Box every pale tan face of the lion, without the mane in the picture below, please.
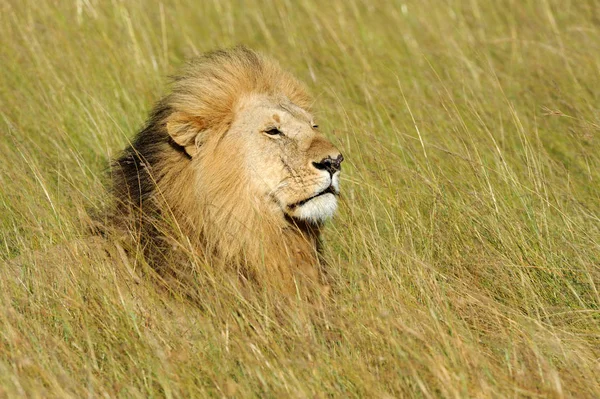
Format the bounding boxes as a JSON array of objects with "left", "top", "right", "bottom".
[{"left": 227, "top": 95, "right": 343, "bottom": 223}]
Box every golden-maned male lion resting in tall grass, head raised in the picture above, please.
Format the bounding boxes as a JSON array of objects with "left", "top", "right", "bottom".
[{"left": 112, "top": 47, "right": 344, "bottom": 288}]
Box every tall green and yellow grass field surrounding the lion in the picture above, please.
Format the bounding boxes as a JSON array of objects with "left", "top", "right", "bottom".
[{"left": 0, "top": 0, "right": 600, "bottom": 398}]
